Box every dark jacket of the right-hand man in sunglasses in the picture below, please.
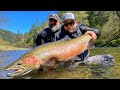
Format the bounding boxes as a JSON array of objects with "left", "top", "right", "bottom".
[{"left": 57, "top": 24, "right": 101, "bottom": 60}]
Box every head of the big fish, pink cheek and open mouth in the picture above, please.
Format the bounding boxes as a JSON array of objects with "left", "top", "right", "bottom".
[{"left": 5, "top": 56, "right": 39, "bottom": 77}]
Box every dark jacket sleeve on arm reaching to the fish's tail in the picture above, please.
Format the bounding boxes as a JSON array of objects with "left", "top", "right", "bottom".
[{"left": 79, "top": 24, "right": 101, "bottom": 38}]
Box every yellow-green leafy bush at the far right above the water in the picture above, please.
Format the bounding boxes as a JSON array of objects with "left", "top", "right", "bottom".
[{"left": 95, "top": 12, "right": 120, "bottom": 46}]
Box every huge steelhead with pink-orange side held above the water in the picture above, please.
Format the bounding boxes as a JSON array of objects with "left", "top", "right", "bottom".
[{"left": 5, "top": 35, "right": 93, "bottom": 77}]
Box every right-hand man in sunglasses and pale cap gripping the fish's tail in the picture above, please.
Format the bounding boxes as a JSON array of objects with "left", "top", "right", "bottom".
[{"left": 59, "top": 13, "right": 101, "bottom": 67}]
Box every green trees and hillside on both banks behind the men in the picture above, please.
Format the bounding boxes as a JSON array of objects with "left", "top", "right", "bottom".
[{"left": 0, "top": 11, "right": 120, "bottom": 48}]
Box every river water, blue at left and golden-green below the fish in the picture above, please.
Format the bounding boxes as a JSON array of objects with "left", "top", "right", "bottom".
[{"left": 0, "top": 47, "right": 120, "bottom": 79}]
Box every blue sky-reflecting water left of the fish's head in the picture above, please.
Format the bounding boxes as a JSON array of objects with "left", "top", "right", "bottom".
[{"left": 0, "top": 50, "right": 28, "bottom": 79}]
